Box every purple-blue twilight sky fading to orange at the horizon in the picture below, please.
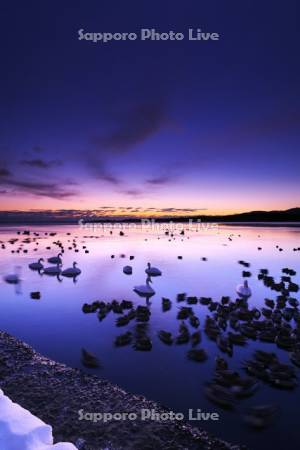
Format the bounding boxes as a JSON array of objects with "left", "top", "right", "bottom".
[{"left": 0, "top": 0, "right": 300, "bottom": 215}]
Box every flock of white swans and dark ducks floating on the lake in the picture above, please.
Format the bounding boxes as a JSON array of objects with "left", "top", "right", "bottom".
[{"left": 2, "top": 232, "right": 300, "bottom": 428}]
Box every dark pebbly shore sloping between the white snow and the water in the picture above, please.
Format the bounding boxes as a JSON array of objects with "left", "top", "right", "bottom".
[{"left": 0, "top": 331, "right": 246, "bottom": 450}]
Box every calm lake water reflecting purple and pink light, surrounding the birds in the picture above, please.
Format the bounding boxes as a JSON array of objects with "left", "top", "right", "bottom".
[{"left": 0, "top": 225, "right": 300, "bottom": 450}]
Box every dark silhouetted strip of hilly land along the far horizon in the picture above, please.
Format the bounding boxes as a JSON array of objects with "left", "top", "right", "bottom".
[{"left": 0, "top": 208, "right": 300, "bottom": 225}]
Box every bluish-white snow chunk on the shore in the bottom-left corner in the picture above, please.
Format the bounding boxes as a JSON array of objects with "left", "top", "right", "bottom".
[{"left": 0, "top": 389, "right": 76, "bottom": 450}]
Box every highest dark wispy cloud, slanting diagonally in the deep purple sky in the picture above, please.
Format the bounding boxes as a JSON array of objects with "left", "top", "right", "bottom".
[{"left": 94, "top": 103, "right": 166, "bottom": 153}]
